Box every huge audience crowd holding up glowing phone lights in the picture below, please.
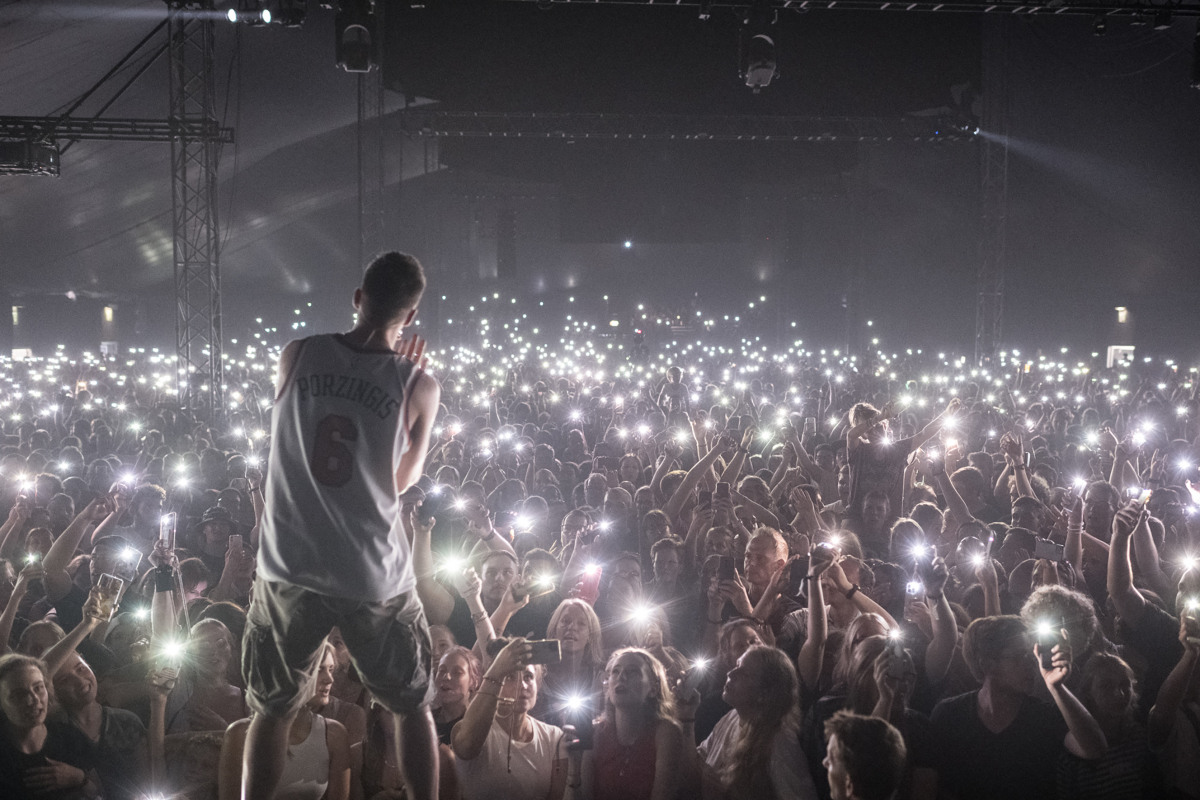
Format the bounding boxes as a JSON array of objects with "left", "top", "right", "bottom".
[{"left": 0, "top": 266, "right": 1200, "bottom": 800}]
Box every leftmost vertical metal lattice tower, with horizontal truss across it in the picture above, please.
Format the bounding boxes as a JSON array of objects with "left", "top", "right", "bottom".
[{"left": 167, "top": 0, "right": 224, "bottom": 416}]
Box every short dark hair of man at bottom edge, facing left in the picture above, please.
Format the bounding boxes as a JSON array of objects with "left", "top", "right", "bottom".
[{"left": 826, "top": 711, "right": 907, "bottom": 800}]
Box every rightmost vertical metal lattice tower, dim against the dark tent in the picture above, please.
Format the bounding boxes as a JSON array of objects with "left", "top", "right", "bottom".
[{"left": 976, "top": 17, "right": 1009, "bottom": 365}]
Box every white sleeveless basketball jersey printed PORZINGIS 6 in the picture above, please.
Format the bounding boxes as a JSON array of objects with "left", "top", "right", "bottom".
[{"left": 258, "top": 335, "right": 418, "bottom": 601}]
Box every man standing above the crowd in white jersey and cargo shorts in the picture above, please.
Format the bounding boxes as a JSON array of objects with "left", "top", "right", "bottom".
[{"left": 241, "top": 252, "right": 442, "bottom": 800}]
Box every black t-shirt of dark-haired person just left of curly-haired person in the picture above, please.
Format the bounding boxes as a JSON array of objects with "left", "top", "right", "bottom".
[{"left": 932, "top": 691, "right": 1067, "bottom": 800}]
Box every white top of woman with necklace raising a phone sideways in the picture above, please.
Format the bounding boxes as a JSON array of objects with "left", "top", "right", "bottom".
[{"left": 455, "top": 717, "right": 566, "bottom": 800}]
